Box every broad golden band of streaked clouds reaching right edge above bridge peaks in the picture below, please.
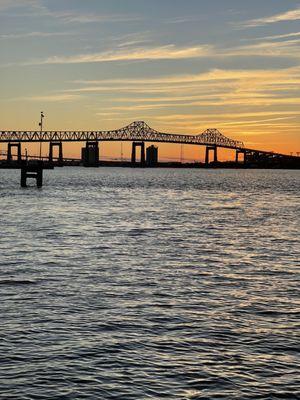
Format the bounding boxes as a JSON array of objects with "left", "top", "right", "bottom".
[{"left": 72, "top": 67, "right": 300, "bottom": 122}]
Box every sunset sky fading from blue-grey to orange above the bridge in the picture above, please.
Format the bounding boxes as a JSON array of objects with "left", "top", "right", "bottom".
[{"left": 0, "top": 0, "right": 300, "bottom": 159}]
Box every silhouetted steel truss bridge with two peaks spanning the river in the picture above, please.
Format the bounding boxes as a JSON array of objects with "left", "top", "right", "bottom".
[{"left": 0, "top": 121, "right": 298, "bottom": 164}]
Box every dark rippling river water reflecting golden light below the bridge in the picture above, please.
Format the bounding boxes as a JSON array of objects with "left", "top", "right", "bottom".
[{"left": 0, "top": 168, "right": 300, "bottom": 400}]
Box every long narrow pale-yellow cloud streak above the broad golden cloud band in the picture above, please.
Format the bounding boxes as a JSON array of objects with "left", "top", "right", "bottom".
[{"left": 23, "top": 45, "right": 210, "bottom": 65}]
